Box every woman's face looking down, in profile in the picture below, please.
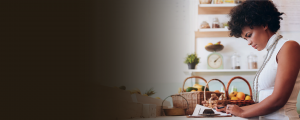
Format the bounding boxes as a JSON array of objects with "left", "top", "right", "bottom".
[{"left": 242, "top": 26, "right": 271, "bottom": 51}]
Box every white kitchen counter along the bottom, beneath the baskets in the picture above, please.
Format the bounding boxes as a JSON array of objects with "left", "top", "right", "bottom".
[{"left": 122, "top": 116, "right": 268, "bottom": 120}]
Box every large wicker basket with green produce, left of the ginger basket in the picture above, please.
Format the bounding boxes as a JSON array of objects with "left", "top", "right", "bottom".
[{"left": 172, "top": 76, "right": 223, "bottom": 115}]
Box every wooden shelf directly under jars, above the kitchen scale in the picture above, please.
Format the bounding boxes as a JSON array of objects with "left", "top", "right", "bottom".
[{"left": 195, "top": 29, "right": 230, "bottom": 38}]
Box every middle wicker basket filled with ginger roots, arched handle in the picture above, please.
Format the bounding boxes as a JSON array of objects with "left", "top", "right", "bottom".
[{"left": 202, "top": 79, "right": 230, "bottom": 108}]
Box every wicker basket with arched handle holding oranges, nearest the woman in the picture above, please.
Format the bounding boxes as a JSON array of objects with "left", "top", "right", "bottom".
[{"left": 225, "top": 76, "right": 254, "bottom": 107}]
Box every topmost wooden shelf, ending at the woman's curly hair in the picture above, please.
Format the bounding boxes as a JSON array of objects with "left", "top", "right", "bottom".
[{"left": 198, "top": 4, "right": 237, "bottom": 14}]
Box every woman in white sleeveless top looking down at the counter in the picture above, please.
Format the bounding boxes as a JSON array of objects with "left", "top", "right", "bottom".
[{"left": 216, "top": 1, "right": 300, "bottom": 120}]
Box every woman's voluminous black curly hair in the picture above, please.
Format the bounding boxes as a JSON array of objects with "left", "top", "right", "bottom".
[{"left": 228, "top": 0, "right": 284, "bottom": 38}]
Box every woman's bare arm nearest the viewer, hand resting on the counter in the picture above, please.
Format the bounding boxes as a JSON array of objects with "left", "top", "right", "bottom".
[{"left": 227, "top": 41, "right": 300, "bottom": 117}]
